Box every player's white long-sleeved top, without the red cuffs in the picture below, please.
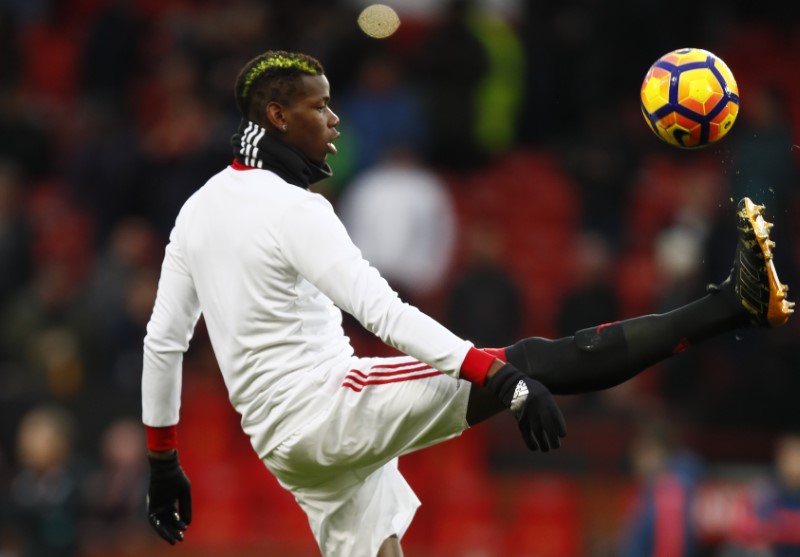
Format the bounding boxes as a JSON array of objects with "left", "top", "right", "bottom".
[{"left": 142, "top": 165, "right": 472, "bottom": 458}]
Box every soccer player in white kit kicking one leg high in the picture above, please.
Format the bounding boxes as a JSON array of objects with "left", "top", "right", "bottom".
[{"left": 142, "top": 51, "right": 792, "bottom": 557}]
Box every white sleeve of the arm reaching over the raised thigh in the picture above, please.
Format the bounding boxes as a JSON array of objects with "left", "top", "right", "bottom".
[{"left": 281, "top": 193, "right": 472, "bottom": 377}]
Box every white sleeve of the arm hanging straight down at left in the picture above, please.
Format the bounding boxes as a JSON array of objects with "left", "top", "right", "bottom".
[{"left": 142, "top": 226, "right": 200, "bottom": 427}]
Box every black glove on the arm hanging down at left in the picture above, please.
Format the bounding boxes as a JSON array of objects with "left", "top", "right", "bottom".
[{"left": 147, "top": 451, "right": 192, "bottom": 545}]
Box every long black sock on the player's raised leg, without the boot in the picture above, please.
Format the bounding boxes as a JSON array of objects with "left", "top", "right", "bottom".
[{"left": 506, "top": 288, "right": 747, "bottom": 394}]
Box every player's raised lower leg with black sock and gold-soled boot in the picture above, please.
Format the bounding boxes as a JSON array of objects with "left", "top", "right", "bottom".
[{"left": 504, "top": 198, "right": 794, "bottom": 394}]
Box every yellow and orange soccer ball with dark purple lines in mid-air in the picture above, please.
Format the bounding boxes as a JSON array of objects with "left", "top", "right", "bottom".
[{"left": 641, "top": 48, "right": 739, "bottom": 149}]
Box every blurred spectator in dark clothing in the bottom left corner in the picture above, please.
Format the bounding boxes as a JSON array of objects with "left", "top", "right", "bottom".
[{"left": 4, "top": 406, "right": 85, "bottom": 557}]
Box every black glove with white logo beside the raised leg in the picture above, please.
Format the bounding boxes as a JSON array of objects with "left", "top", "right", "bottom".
[{"left": 486, "top": 364, "right": 567, "bottom": 452}]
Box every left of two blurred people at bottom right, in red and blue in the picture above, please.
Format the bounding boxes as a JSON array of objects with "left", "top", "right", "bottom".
[{"left": 619, "top": 420, "right": 703, "bottom": 557}]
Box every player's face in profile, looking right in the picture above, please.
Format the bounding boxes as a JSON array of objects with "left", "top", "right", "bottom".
[{"left": 283, "top": 75, "right": 339, "bottom": 163}]
